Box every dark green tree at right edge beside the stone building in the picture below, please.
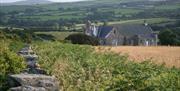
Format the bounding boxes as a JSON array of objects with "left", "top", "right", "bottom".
[{"left": 159, "top": 29, "right": 180, "bottom": 45}]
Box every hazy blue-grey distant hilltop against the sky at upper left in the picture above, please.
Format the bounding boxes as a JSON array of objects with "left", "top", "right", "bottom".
[{"left": 1, "top": 0, "right": 53, "bottom": 6}]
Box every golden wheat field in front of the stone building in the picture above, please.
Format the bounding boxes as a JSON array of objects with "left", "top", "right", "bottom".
[{"left": 96, "top": 46, "right": 180, "bottom": 68}]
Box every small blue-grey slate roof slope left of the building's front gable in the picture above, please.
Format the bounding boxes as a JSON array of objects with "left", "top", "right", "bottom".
[{"left": 98, "top": 26, "right": 113, "bottom": 38}]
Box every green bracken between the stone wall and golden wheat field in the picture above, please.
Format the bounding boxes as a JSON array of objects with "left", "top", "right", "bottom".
[{"left": 34, "top": 42, "right": 180, "bottom": 91}]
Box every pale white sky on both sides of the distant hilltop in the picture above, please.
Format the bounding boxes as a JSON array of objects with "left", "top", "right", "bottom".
[{"left": 0, "top": 0, "right": 87, "bottom": 3}]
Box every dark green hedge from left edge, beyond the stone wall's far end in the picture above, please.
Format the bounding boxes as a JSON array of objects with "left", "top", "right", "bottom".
[{"left": 0, "top": 28, "right": 55, "bottom": 42}]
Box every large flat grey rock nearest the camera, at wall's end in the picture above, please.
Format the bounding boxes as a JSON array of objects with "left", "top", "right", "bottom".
[{"left": 9, "top": 74, "right": 59, "bottom": 91}]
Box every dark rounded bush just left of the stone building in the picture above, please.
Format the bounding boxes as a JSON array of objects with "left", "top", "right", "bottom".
[{"left": 65, "top": 34, "right": 99, "bottom": 46}]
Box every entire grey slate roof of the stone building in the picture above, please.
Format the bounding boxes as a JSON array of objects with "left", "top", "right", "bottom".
[{"left": 98, "top": 24, "right": 155, "bottom": 38}]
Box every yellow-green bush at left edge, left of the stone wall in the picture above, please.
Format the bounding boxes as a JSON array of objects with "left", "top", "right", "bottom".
[{"left": 0, "top": 40, "right": 25, "bottom": 91}]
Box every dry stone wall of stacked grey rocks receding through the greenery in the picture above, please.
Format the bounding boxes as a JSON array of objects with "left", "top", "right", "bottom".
[{"left": 8, "top": 45, "right": 60, "bottom": 91}]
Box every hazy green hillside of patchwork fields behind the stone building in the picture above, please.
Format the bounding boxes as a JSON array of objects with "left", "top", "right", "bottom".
[{"left": 0, "top": 0, "right": 180, "bottom": 28}]
